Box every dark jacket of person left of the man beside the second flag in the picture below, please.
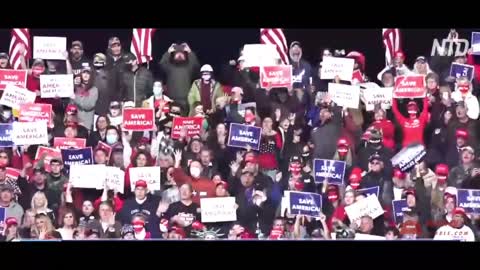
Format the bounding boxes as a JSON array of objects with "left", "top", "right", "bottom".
[{"left": 94, "top": 68, "right": 119, "bottom": 115}]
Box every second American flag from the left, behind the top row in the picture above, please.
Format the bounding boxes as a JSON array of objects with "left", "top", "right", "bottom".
[{"left": 130, "top": 28, "right": 155, "bottom": 64}]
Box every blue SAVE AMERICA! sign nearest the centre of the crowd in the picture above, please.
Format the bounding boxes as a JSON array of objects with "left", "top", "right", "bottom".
[{"left": 227, "top": 123, "right": 262, "bottom": 151}]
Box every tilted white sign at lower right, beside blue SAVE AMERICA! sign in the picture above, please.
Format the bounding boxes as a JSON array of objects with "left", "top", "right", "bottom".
[{"left": 345, "top": 194, "right": 384, "bottom": 223}]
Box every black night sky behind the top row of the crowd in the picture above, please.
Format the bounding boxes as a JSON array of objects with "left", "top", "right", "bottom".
[{"left": 0, "top": 28, "right": 475, "bottom": 79}]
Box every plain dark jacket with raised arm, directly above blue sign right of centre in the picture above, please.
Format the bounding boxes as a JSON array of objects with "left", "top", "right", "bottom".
[{"left": 310, "top": 106, "right": 342, "bottom": 159}]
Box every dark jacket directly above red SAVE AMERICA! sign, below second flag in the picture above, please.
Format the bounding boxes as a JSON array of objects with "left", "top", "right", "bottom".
[{"left": 120, "top": 66, "right": 153, "bottom": 107}]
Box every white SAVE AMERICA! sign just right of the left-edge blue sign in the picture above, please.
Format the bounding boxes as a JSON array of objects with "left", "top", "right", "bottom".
[{"left": 12, "top": 121, "right": 48, "bottom": 145}]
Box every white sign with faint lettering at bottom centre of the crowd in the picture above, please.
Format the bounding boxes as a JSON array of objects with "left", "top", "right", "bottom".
[{"left": 200, "top": 197, "right": 237, "bottom": 223}]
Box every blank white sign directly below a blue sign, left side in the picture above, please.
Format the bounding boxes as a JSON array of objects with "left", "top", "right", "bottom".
[{"left": 69, "top": 164, "right": 106, "bottom": 188}]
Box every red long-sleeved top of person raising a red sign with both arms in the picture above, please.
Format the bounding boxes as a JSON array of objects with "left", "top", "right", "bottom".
[{"left": 392, "top": 98, "right": 428, "bottom": 147}]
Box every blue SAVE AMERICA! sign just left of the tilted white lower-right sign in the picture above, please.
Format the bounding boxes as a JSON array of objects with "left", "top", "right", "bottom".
[{"left": 289, "top": 191, "right": 322, "bottom": 217}]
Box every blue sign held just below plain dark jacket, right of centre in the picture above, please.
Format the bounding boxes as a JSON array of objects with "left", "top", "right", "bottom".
[{"left": 313, "top": 159, "right": 346, "bottom": 185}]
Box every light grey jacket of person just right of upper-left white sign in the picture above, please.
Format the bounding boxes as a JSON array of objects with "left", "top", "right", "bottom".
[{"left": 72, "top": 86, "right": 98, "bottom": 130}]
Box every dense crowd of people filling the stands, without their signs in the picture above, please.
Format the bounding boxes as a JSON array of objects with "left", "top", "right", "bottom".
[{"left": 0, "top": 28, "right": 480, "bottom": 241}]
